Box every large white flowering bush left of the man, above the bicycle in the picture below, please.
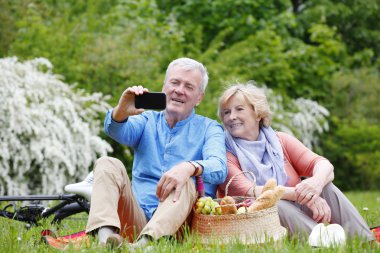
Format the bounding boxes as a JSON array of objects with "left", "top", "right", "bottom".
[{"left": 0, "top": 57, "right": 112, "bottom": 195}]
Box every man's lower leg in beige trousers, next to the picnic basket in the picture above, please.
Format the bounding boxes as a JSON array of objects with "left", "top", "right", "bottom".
[{"left": 139, "top": 179, "right": 197, "bottom": 239}]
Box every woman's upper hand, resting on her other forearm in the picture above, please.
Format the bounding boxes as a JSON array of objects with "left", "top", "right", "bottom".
[{"left": 294, "top": 176, "right": 324, "bottom": 205}]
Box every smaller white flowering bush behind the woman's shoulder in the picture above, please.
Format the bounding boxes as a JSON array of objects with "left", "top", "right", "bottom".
[{"left": 262, "top": 86, "right": 329, "bottom": 149}]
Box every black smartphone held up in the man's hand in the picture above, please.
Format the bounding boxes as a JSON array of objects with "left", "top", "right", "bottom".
[{"left": 135, "top": 92, "right": 166, "bottom": 110}]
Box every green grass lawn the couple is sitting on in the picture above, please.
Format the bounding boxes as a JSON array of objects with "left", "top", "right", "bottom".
[{"left": 0, "top": 192, "right": 380, "bottom": 253}]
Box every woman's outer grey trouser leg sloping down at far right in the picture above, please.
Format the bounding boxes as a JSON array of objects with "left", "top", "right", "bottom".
[{"left": 321, "top": 183, "right": 375, "bottom": 241}]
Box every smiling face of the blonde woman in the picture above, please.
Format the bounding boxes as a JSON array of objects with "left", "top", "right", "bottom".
[{"left": 222, "top": 94, "right": 261, "bottom": 141}]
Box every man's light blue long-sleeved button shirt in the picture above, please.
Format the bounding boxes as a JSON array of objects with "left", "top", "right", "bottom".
[{"left": 104, "top": 109, "right": 227, "bottom": 219}]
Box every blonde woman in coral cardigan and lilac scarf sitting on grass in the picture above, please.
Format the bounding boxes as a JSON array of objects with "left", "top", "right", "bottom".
[{"left": 218, "top": 84, "right": 374, "bottom": 241}]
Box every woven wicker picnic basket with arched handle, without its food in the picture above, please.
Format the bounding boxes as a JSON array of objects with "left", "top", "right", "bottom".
[{"left": 191, "top": 171, "right": 286, "bottom": 244}]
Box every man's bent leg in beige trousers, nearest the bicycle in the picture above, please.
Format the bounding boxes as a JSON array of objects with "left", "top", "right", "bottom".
[{"left": 86, "top": 157, "right": 147, "bottom": 240}]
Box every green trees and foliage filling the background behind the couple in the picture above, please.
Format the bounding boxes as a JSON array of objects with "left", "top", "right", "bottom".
[{"left": 0, "top": 0, "right": 380, "bottom": 190}]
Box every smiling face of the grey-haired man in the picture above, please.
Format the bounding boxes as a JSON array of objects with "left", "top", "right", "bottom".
[{"left": 162, "top": 66, "right": 203, "bottom": 119}]
